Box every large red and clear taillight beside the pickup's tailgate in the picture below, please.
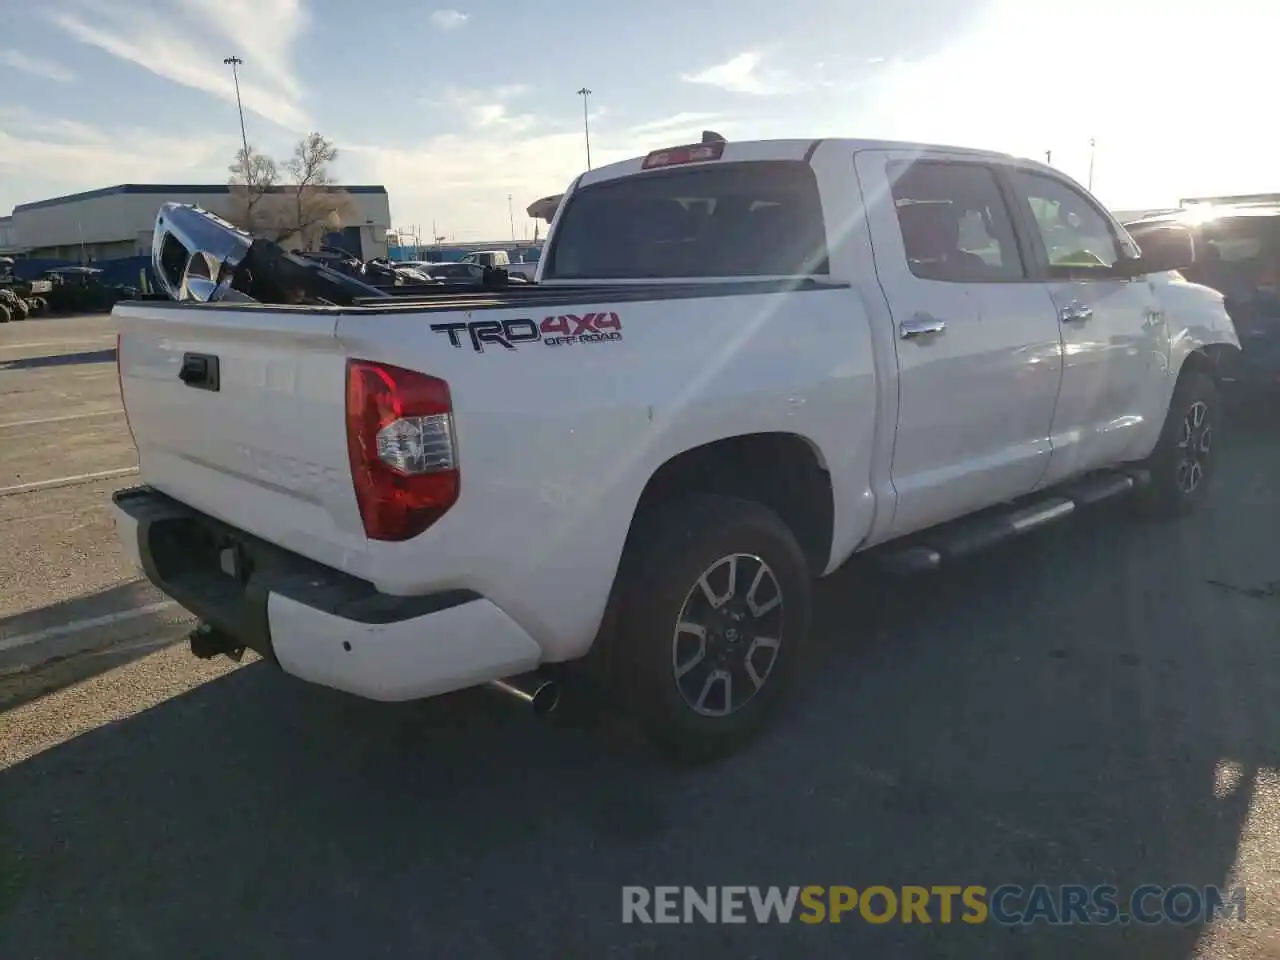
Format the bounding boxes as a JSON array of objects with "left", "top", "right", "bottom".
[{"left": 347, "top": 360, "right": 460, "bottom": 540}]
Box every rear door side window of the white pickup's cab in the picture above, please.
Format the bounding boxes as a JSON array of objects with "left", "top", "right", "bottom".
[{"left": 890, "top": 160, "right": 1025, "bottom": 283}]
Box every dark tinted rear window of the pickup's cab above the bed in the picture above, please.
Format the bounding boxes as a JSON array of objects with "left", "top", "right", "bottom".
[{"left": 543, "top": 160, "right": 829, "bottom": 280}]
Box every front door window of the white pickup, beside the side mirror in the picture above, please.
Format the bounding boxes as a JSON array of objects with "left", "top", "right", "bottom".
[{"left": 1014, "top": 170, "right": 1120, "bottom": 278}]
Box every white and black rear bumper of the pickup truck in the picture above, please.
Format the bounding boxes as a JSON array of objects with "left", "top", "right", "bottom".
[{"left": 113, "top": 486, "right": 541, "bottom": 700}]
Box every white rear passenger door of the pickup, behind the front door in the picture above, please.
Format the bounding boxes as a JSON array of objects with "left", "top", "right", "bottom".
[{"left": 855, "top": 151, "right": 1062, "bottom": 536}]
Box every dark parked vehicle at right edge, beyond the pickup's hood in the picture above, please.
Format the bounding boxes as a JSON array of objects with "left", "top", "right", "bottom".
[{"left": 1125, "top": 202, "right": 1280, "bottom": 389}]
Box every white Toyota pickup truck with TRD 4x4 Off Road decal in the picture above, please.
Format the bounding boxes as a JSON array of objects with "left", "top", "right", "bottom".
[{"left": 114, "top": 140, "right": 1239, "bottom": 755}]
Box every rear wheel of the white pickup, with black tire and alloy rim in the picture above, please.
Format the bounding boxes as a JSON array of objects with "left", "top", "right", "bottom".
[{"left": 612, "top": 495, "right": 813, "bottom": 760}]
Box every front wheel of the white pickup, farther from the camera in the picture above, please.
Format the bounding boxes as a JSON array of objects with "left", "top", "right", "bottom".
[{"left": 1137, "top": 370, "right": 1221, "bottom": 520}]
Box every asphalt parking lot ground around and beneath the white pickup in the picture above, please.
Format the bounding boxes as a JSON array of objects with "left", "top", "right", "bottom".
[{"left": 0, "top": 317, "right": 1280, "bottom": 960}]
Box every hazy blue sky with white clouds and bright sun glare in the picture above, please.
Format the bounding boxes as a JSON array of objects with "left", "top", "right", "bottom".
[{"left": 0, "top": 0, "right": 1280, "bottom": 241}]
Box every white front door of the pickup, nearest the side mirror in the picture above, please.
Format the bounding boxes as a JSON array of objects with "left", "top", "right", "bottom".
[{"left": 1010, "top": 170, "right": 1169, "bottom": 483}]
